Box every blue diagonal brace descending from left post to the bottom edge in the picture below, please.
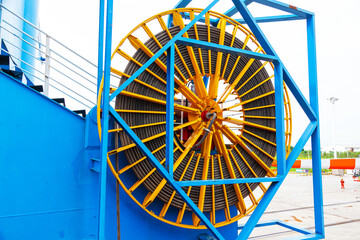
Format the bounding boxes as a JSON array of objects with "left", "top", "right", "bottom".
[{"left": 110, "top": 106, "right": 225, "bottom": 240}]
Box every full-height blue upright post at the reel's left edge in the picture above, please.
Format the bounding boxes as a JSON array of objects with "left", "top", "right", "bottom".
[{"left": 98, "top": 0, "right": 113, "bottom": 240}]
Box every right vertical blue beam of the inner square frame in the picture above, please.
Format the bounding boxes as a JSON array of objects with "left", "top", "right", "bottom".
[{"left": 274, "top": 61, "right": 286, "bottom": 176}]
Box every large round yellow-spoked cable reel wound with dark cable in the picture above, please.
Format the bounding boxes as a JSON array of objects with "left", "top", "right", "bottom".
[{"left": 100, "top": 9, "right": 291, "bottom": 228}]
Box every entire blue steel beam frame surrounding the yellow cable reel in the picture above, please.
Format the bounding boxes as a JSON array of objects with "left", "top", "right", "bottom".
[{"left": 99, "top": 0, "right": 324, "bottom": 240}]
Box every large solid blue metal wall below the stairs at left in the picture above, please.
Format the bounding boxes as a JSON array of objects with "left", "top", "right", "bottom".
[{"left": 0, "top": 73, "right": 98, "bottom": 240}]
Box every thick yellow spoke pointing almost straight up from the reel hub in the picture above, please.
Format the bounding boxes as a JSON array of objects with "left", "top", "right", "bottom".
[{"left": 209, "top": 18, "right": 226, "bottom": 99}]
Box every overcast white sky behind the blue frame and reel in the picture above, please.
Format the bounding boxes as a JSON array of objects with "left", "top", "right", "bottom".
[{"left": 40, "top": 0, "right": 360, "bottom": 151}]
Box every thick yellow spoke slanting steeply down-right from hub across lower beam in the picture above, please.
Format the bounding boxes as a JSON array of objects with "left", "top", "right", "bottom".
[{"left": 214, "top": 128, "right": 246, "bottom": 214}]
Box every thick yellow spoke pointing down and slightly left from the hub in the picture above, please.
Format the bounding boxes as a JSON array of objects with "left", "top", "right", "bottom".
[{"left": 192, "top": 132, "right": 213, "bottom": 226}]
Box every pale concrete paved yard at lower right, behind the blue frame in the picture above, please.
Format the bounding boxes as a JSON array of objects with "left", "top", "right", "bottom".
[{"left": 242, "top": 175, "right": 360, "bottom": 240}]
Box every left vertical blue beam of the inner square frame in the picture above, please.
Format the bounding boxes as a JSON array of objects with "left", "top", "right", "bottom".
[{"left": 165, "top": 45, "right": 175, "bottom": 178}]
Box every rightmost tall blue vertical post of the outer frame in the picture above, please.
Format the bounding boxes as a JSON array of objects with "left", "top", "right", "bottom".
[{"left": 306, "top": 15, "right": 325, "bottom": 236}]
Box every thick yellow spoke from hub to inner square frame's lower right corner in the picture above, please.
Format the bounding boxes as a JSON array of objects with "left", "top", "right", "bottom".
[{"left": 215, "top": 122, "right": 275, "bottom": 177}]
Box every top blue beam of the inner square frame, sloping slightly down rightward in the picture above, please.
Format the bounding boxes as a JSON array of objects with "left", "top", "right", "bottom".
[{"left": 176, "top": 37, "right": 277, "bottom": 62}]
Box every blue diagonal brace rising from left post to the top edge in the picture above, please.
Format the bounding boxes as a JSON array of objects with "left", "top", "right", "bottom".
[{"left": 110, "top": 0, "right": 219, "bottom": 101}]
